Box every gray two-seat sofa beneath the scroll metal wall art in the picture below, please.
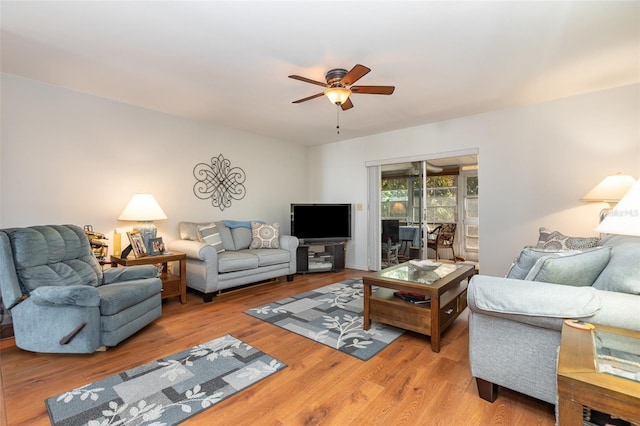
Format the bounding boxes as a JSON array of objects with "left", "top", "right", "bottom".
[{"left": 167, "top": 220, "right": 298, "bottom": 302}]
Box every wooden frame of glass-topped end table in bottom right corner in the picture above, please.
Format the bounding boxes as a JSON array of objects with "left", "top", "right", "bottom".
[{"left": 558, "top": 324, "right": 640, "bottom": 426}]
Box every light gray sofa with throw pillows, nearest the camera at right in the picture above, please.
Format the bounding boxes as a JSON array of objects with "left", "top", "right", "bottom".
[{"left": 467, "top": 235, "right": 640, "bottom": 404}]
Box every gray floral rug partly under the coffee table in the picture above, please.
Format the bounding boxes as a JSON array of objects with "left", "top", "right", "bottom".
[{"left": 245, "top": 278, "right": 403, "bottom": 361}]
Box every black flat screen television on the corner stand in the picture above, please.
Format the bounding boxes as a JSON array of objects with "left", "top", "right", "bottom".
[{"left": 291, "top": 204, "right": 351, "bottom": 242}]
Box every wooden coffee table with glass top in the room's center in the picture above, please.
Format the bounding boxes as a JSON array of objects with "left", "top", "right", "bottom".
[{"left": 362, "top": 262, "right": 476, "bottom": 352}]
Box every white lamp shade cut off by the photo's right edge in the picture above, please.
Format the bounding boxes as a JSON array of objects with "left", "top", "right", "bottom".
[{"left": 596, "top": 180, "right": 640, "bottom": 237}]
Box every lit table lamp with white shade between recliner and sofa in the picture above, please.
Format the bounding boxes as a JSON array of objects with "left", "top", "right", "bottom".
[{"left": 118, "top": 194, "right": 167, "bottom": 257}]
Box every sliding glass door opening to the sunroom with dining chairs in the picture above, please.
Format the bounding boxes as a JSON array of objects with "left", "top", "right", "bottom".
[{"left": 367, "top": 150, "right": 479, "bottom": 270}]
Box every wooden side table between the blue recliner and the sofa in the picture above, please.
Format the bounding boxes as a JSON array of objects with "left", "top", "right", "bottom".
[{"left": 111, "top": 251, "right": 187, "bottom": 304}]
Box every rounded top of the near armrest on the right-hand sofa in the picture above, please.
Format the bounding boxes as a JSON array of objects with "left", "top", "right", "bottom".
[{"left": 467, "top": 275, "right": 601, "bottom": 318}]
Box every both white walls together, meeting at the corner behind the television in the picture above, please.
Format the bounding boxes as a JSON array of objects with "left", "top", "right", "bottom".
[{"left": 0, "top": 75, "right": 640, "bottom": 275}]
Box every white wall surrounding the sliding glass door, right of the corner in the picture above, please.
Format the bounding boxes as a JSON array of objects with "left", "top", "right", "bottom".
[{"left": 309, "top": 85, "right": 640, "bottom": 275}]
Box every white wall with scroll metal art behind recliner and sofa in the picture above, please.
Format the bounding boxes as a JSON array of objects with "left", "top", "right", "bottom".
[{"left": 0, "top": 74, "right": 308, "bottom": 244}]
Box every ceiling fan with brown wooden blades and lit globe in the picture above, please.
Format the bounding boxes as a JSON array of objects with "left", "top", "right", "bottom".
[{"left": 289, "top": 64, "right": 395, "bottom": 111}]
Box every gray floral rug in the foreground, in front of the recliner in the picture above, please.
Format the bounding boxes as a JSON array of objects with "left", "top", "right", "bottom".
[{"left": 46, "top": 335, "right": 286, "bottom": 426}]
